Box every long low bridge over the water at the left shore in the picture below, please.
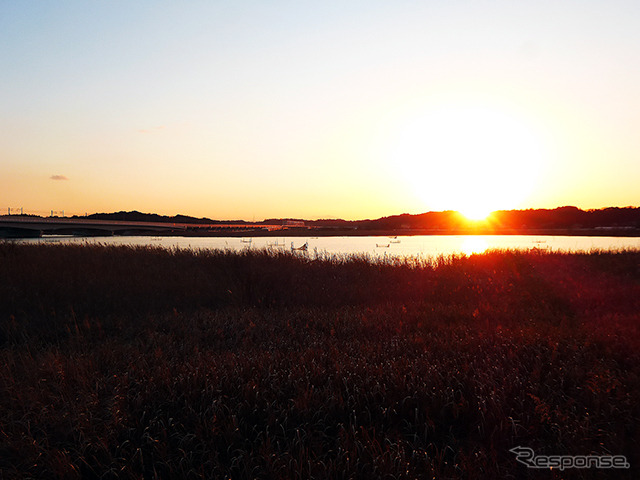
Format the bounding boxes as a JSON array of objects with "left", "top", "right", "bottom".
[{"left": 0, "top": 215, "right": 282, "bottom": 238}]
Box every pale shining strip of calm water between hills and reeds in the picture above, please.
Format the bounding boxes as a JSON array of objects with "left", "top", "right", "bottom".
[{"left": 24, "top": 235, "right": 640, "bottom": 257}]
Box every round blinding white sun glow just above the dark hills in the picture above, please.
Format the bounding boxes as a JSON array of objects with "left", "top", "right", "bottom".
[{"left": 391, "top": 105, "right": 547, "bottom": 216}]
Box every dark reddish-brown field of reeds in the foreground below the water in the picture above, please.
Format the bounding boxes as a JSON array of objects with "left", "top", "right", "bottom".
[{"left": 0, "top": 243, "right": 640, "bottom": 479}]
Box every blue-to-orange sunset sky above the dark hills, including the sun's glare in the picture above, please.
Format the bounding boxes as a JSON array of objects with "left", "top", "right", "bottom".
[{"left": 0, "top": 0, "right": 640, "bottom": 220}]
